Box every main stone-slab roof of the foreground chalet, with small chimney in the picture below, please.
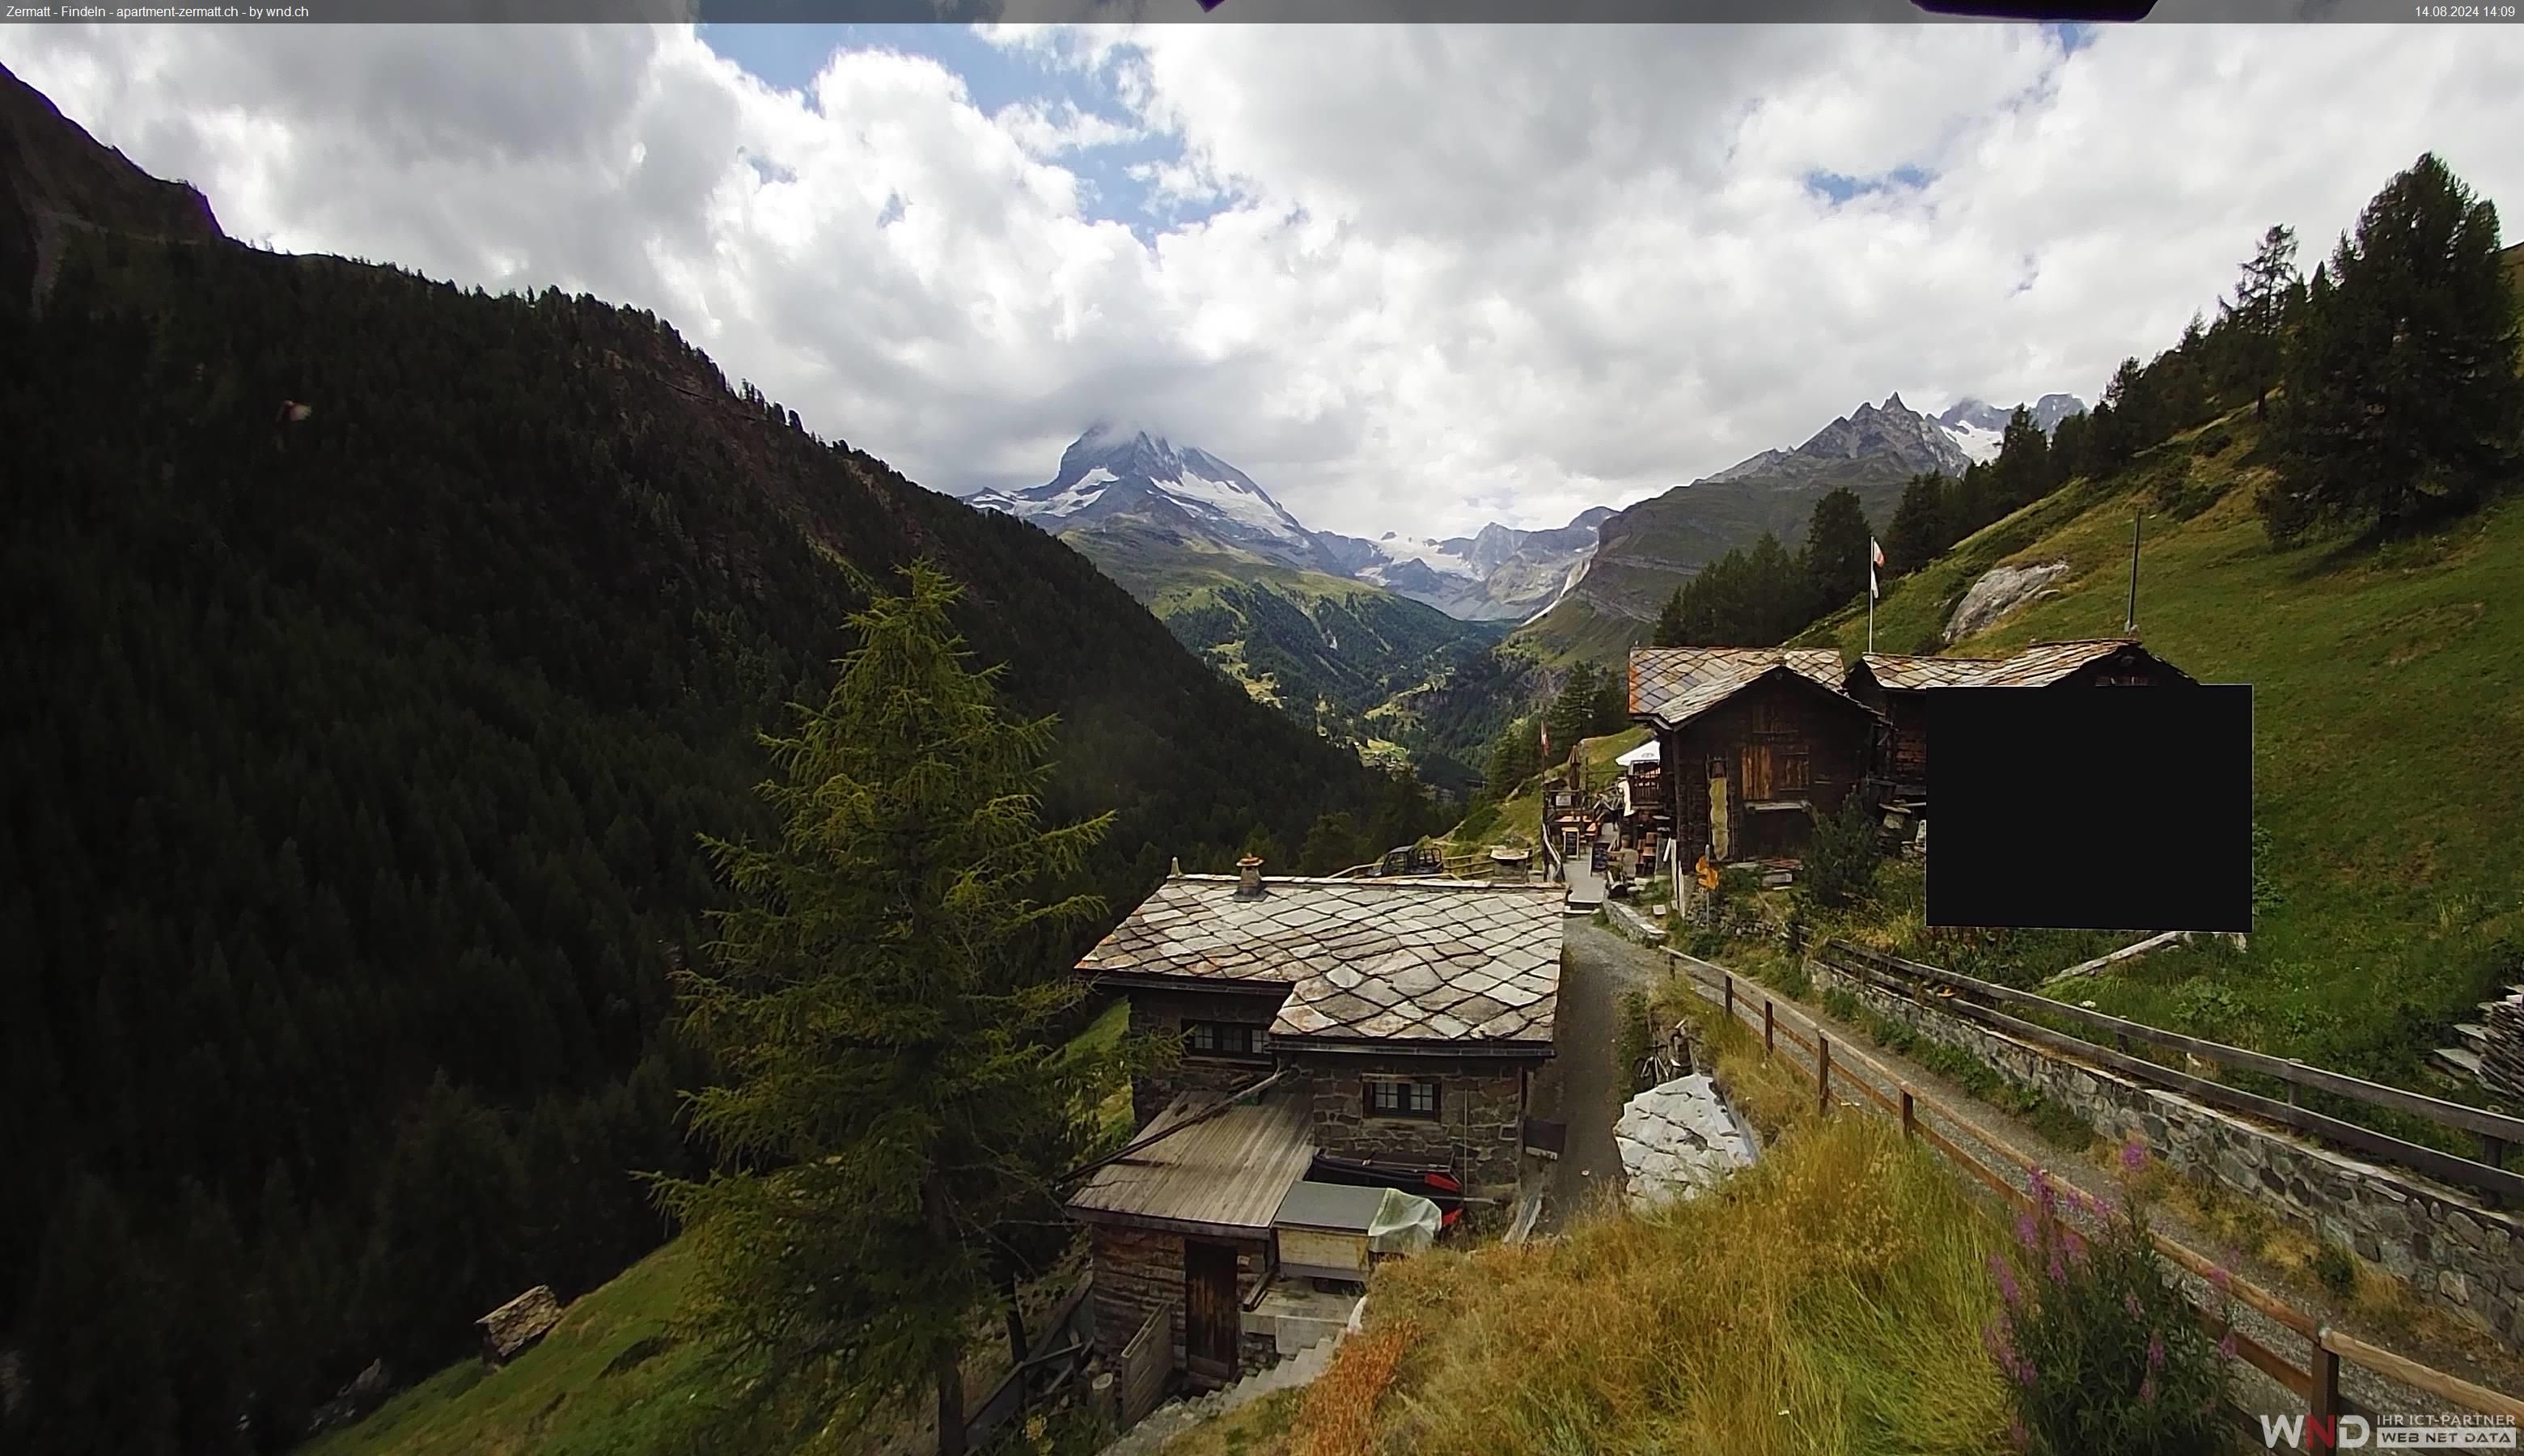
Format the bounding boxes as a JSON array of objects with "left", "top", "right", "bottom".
[{"left": 1078, "top": 875, "right": 1562, "bottom": 1050}]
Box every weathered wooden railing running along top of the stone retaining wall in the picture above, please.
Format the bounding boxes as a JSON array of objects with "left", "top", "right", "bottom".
[{"left": 1815, "top": 938, "right": 2524, "bottom": 1206}]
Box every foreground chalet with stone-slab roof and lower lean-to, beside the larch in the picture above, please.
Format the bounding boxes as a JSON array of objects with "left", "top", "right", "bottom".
[{"left": 1070, "top": 861, "right": 1562, "bottom": 1380}]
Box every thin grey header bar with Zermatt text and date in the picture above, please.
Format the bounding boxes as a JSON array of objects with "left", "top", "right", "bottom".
[{"left": 5, "top": 0, "right": 2524, "bottom": 25}]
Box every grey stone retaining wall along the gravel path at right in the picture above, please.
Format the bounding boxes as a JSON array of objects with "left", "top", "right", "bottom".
[{"left": 1807, "top": 959, "right": 2524, "bottom": 1348}]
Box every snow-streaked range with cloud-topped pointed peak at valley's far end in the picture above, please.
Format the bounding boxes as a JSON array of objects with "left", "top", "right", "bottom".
[{"left": 964, "top": 424, "right": 1613, "bottom": 620}]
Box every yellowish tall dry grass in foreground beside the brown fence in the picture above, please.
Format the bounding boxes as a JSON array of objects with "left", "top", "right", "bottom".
[{"left": 1322, "top": 963, "right": 2009, "bottom": 1456}]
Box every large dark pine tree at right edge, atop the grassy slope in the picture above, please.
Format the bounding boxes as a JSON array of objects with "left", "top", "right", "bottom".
[{"left": 2262, "top": 154, "right": 2524, "bottom": 540}]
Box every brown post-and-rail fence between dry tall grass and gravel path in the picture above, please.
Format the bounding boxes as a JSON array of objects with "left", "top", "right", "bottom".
[{"left": 1666, "top": 951, "right": 2524, "bottom": 1423}]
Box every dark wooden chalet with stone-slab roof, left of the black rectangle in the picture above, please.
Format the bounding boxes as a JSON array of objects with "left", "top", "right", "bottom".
[{"left": 1631, "top": 646, "right": 1883, "bottom": 868}]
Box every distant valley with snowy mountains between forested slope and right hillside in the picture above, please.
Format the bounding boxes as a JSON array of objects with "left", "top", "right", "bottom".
[{"left": 964, "top": 394, "right": 2085, "bottom": 787}]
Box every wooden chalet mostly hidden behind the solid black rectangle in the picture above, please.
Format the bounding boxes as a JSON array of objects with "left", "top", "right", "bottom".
[{"left": 1840, "top": 638, "right": 2193, "bottom": 807}]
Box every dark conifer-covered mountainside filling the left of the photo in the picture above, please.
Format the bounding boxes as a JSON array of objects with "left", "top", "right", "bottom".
[{"left": 0, "top": 111, "right": 1429, "bottom": 1456}]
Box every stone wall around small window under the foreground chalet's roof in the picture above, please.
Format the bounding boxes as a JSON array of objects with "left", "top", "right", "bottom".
[{"left": 1282, "top": 1052, "right": 1537, "bottom": 1199}]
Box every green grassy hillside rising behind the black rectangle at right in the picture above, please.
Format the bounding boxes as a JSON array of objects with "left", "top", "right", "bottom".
[{"left": 1800, "top": 408, "right": 2524, "bottom": 1082}]
